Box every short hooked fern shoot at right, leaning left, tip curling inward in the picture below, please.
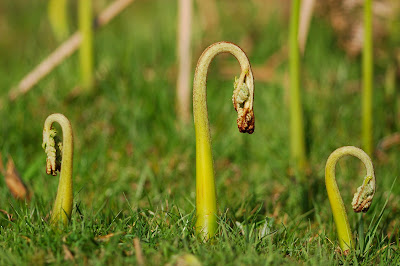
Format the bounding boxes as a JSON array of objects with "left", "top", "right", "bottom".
[{"left": 325, "top": 146, "right": 375, "bottom": 254}]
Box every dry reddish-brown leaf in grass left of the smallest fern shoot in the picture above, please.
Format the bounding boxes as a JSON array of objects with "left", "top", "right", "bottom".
[{"left": 4, "top": 156, "right": 31, "bottom": 201}]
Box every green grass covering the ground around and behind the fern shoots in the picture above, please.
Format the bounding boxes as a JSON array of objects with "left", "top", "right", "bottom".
[{"left": 0, "top": 0, "right": 400, "bottom": 265}]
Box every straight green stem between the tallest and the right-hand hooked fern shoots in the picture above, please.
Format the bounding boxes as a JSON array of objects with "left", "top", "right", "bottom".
[{"left": 289, "top": 0, "right": 306, "bottom": 175}]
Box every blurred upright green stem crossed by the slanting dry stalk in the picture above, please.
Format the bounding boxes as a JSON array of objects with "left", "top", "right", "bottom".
[{"left": 79, "top": 0, "right": 93, "bottom": 91}]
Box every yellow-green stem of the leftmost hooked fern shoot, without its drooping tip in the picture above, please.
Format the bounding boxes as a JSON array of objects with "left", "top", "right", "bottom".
[{"left": 43, "top": 114, "right": 74, "bottom": 228}]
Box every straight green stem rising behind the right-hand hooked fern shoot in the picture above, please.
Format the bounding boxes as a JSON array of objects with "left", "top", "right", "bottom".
[{"left": 362, "top": 0, "right": 373, "bottom": 155}]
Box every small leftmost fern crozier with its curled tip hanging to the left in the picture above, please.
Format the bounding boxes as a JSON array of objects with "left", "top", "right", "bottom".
[{"left": 42, "top": 114, "right": 74, "bottom": 225}]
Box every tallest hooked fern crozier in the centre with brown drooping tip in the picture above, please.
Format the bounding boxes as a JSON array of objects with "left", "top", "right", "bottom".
[{"left": 193, "top": 42, "right": 254, "bottom": 240}]
